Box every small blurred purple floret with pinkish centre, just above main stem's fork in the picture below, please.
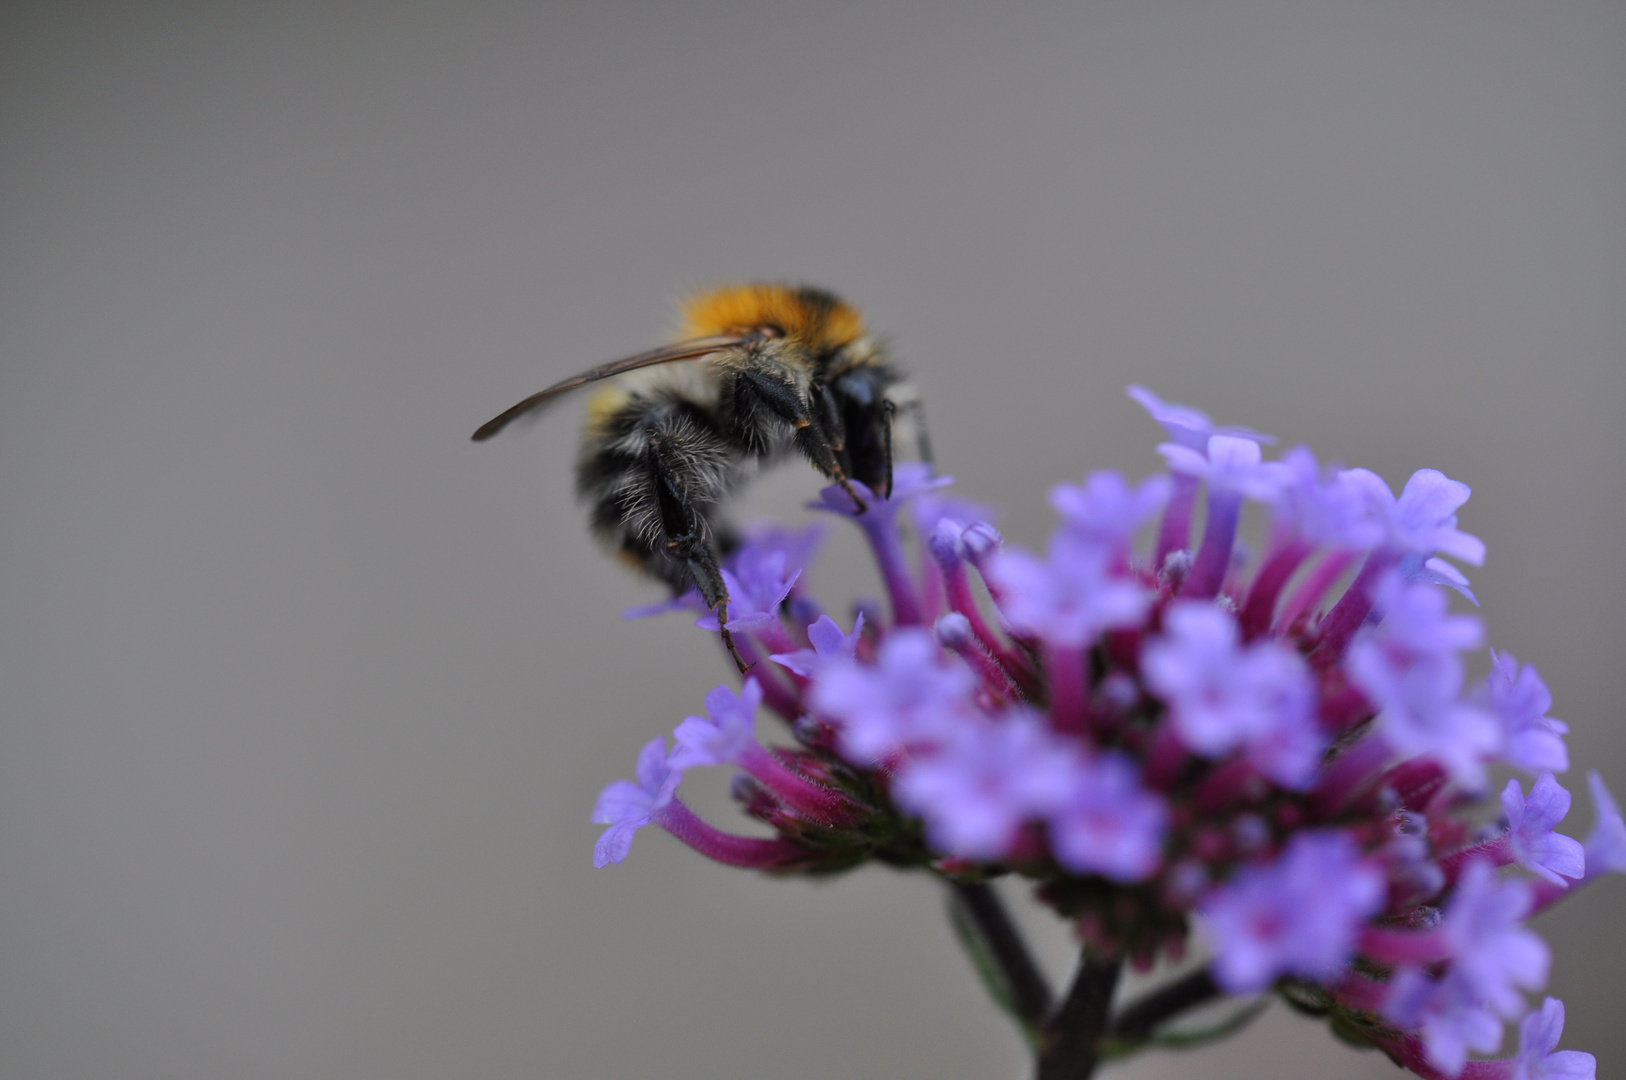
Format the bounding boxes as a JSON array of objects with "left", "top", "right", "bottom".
[{"left": 1049, "top": 753, "right": 1169, "bottom": 882}]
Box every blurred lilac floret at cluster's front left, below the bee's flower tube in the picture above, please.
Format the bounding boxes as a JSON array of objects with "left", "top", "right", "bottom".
[{"left": 813, "top": 628, "right": 976, "bottom": 764}]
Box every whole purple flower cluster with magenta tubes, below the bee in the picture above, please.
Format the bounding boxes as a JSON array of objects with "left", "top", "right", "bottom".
[{"left": 593, "top": 387, "right": 1626, "bottom": 1077}]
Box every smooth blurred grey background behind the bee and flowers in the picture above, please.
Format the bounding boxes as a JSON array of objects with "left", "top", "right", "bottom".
[{"left": 0, "top": 0, "right": 1626, "bottom": 1080}]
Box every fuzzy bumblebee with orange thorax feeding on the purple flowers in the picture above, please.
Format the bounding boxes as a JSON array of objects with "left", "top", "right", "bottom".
[{"left": 473, "top": 285, "right": 927, "bottom": 672}]
